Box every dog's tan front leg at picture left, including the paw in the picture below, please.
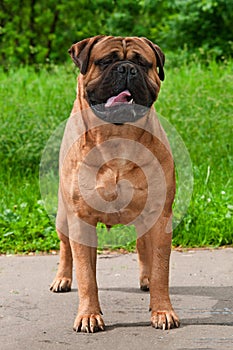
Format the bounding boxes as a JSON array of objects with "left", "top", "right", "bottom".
[{"left": 70, "top": 240, "right": 105, "bottom": 333}]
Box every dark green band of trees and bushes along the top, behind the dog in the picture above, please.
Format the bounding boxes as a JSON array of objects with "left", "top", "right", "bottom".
[{"left": 0, "top": 0, "right": 233, "bottom": 69}]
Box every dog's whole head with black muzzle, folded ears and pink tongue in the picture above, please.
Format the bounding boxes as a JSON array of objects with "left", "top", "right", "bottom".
[{"left": 69, "top": 36, "right": 165, "bottom": 124}]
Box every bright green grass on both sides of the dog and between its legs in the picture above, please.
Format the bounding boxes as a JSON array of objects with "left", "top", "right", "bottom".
[{"left": 0, "top": 57, "right": 233, "bottom": 253}]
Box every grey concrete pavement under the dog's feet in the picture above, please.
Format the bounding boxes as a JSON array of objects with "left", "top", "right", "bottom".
[{"left": 0, "top": 248, "right": 233, "bottom": 350}]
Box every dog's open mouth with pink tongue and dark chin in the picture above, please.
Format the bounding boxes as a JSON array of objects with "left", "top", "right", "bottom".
[{"left": 90, "top": 90, "right": 148, "bottom": 125}]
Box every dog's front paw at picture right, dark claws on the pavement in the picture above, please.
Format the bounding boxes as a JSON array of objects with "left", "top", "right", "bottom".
[{"left": 151, "top": 310, "right": 180, "bottom": 330}]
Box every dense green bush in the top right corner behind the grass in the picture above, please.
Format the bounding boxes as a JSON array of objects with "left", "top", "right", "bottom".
[{"left": 163, "top": 0, "right": 233, "bottom": 59}]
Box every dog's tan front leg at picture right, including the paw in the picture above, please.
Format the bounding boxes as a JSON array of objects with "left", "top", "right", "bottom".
[{"left": 150, "top": 217, "right": 179, "bottom": 329}]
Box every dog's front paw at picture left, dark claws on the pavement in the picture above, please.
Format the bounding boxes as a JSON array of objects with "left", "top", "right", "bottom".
[{"left": 73, "top": 314, "right": 105, "bottom": 333}]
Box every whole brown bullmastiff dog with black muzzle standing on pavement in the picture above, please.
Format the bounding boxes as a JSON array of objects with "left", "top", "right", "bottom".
[{"left": 50, "top": 36, "right": 179, "bottom": 332}]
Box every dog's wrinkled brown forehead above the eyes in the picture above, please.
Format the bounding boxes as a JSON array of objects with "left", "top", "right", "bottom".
[{"left": 92, "top": 37, "right": 155, "bottom": 62}]
